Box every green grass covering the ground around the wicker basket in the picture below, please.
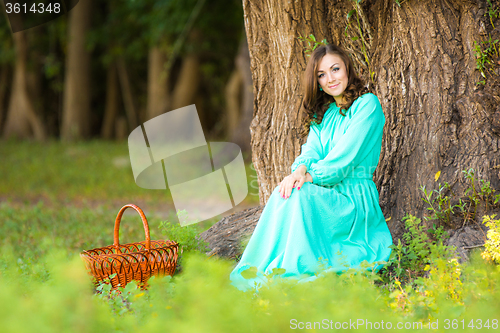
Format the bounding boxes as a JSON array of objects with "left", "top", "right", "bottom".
[{"left": 0, "top": 142, "right": 500, "bottom": 333}]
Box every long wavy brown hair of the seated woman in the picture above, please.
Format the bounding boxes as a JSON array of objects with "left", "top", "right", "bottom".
[{"left": 300, "top": 44, "right": 369, "bottom": 137}]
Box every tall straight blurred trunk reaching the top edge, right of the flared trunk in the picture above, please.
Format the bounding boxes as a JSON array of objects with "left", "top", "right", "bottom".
[{"left": 61, "top": 0, "right": 92, "bottom": 140}]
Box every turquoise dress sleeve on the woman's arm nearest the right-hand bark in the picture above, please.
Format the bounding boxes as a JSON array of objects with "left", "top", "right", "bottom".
[{"left": 307, "top": 93, "right": 385, "bottom": 185}]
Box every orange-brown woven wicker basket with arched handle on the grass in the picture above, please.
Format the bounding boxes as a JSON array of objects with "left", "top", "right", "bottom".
[{"left": 80, "top": 204, "right": 179, "bottom": 289}]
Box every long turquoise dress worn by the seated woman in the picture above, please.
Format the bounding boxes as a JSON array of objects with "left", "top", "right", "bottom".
[{"left": 229, "top": 93, "right": 392, "bottom": 290}]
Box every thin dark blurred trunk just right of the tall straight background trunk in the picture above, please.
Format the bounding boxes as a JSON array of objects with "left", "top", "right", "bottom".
[{"left": 101, "top": 62, "right": 120, "bottom": 140}]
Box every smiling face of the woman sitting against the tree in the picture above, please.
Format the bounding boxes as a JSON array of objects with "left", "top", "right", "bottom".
[{"left": 316, "top": 53, "right": 349, "bottom": 105}]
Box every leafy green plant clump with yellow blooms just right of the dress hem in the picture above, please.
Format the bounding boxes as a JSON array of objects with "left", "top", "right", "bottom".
[{"left": 382, "top": 214, "right": 463, "bottom": 318}]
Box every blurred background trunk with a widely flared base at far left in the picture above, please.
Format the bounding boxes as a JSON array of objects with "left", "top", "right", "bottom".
[{"left": 3, "top": 31, "right": 45, "bottom": 140}]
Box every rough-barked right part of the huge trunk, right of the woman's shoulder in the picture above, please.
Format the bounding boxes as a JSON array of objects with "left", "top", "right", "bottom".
[{"left": 369, "top": 1, "right": 500, "bottom": 236}]
